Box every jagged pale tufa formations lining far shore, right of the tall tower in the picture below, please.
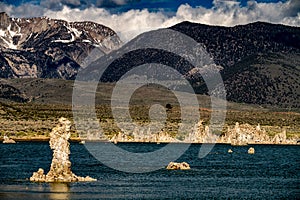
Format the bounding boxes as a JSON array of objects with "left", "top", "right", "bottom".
[{"left": 105, "top": 121, "right": 297, "bottom": 145}]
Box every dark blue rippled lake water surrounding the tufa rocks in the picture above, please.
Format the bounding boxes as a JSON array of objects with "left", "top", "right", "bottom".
[{"left": 0, "top": 142, "right": 300, "bottom": 199}]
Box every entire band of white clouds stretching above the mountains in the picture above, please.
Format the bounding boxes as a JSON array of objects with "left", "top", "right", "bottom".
[{"left": 4, "top": 0, "right": 300, "bottom": 42}]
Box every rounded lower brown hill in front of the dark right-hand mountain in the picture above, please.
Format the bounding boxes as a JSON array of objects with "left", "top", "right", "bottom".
[{"left": 222, "top": 53, "right": 300, "bottom": 108}]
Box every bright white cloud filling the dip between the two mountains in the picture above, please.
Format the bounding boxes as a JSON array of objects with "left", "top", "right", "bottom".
[{"left": 45, "top": 7, "right": 169, "bottom": 41}]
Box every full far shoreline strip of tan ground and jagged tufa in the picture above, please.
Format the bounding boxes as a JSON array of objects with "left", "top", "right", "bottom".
[{"left": 0, "top": 121, "right": 300, "bottom": 146}]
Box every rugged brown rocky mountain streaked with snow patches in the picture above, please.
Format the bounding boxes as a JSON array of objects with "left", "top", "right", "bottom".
[{"left": 0, "top": 13, "right": 121, "bottom": 79}]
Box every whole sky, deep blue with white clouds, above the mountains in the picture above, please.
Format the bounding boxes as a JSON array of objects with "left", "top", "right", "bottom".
[{"left": 0, "top": 0, "right": 300, "bottom": 42}]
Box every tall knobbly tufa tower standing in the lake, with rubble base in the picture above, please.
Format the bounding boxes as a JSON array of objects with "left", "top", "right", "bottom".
[{"left": 30, "top": 117, "right": 97, "bottom": 182}]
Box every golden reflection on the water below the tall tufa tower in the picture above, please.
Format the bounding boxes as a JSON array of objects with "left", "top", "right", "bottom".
[{"left": 50, "top": 183, "right": 70, "bottom": 200}]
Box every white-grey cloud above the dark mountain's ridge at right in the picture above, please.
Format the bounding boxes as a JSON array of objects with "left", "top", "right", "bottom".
[{"left": 171, "top": 1, "right": 300, "bottom": 26}]
